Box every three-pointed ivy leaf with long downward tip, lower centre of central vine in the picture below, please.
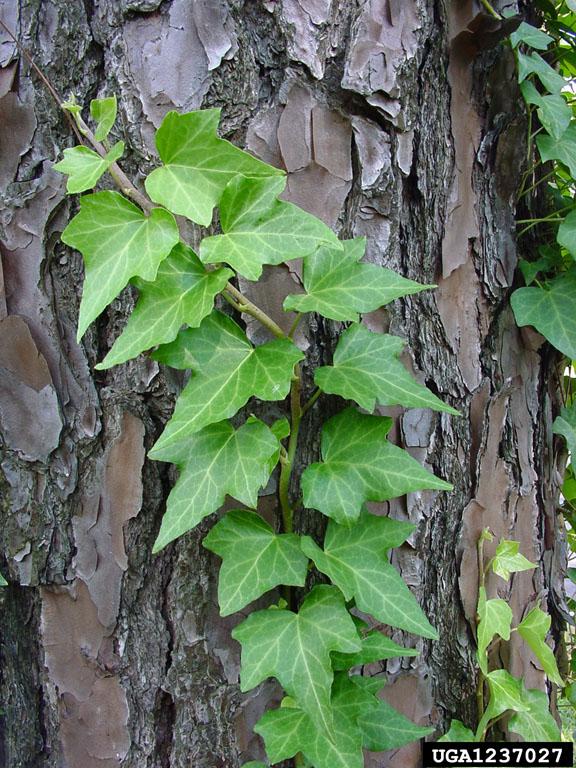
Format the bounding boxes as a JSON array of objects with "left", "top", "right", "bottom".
[{"left": 232, "top": 585, "right": 361, "bottom": 733}]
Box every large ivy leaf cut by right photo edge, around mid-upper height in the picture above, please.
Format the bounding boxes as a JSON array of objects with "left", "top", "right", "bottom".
[{"left": 510, "top": 272, "right": 576, "bottom": 360}]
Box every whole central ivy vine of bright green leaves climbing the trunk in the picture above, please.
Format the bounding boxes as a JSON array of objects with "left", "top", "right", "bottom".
[{"left": 57, "top": 98, "right": 456, "bottom": 768}]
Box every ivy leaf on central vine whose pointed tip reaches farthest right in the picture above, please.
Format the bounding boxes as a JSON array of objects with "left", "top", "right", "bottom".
[{"left": 314, "top": 325, "right": 458, "bottom": 415}]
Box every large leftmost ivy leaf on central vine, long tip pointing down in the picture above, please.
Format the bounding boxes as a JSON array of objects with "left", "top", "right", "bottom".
[{"left": 62, "top": 190, "right": 180, "bottom": 340}]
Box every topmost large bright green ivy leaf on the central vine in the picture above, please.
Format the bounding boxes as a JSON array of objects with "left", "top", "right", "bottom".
[{"left": 145, "top": 109, "right": 283, "bottom": 227}]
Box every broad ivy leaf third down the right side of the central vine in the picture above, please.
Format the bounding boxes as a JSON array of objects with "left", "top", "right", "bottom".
[{"left": 302, "top": 408, "right": 452, "bottom": 522}]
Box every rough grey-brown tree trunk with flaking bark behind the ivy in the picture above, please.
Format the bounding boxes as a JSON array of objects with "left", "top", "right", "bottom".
[{"left": 0, "top": 0, "right": 563, "bottom": 768}]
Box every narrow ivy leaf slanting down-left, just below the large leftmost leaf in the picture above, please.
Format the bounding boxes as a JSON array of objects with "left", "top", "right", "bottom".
[{"left": 96, "top": 243, "right": 233, "bottom": 370}]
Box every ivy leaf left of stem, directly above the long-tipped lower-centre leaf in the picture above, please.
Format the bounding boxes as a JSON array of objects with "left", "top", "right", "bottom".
[{"left": 203, "top": 510, "right": 308, "bottom": 616}]
